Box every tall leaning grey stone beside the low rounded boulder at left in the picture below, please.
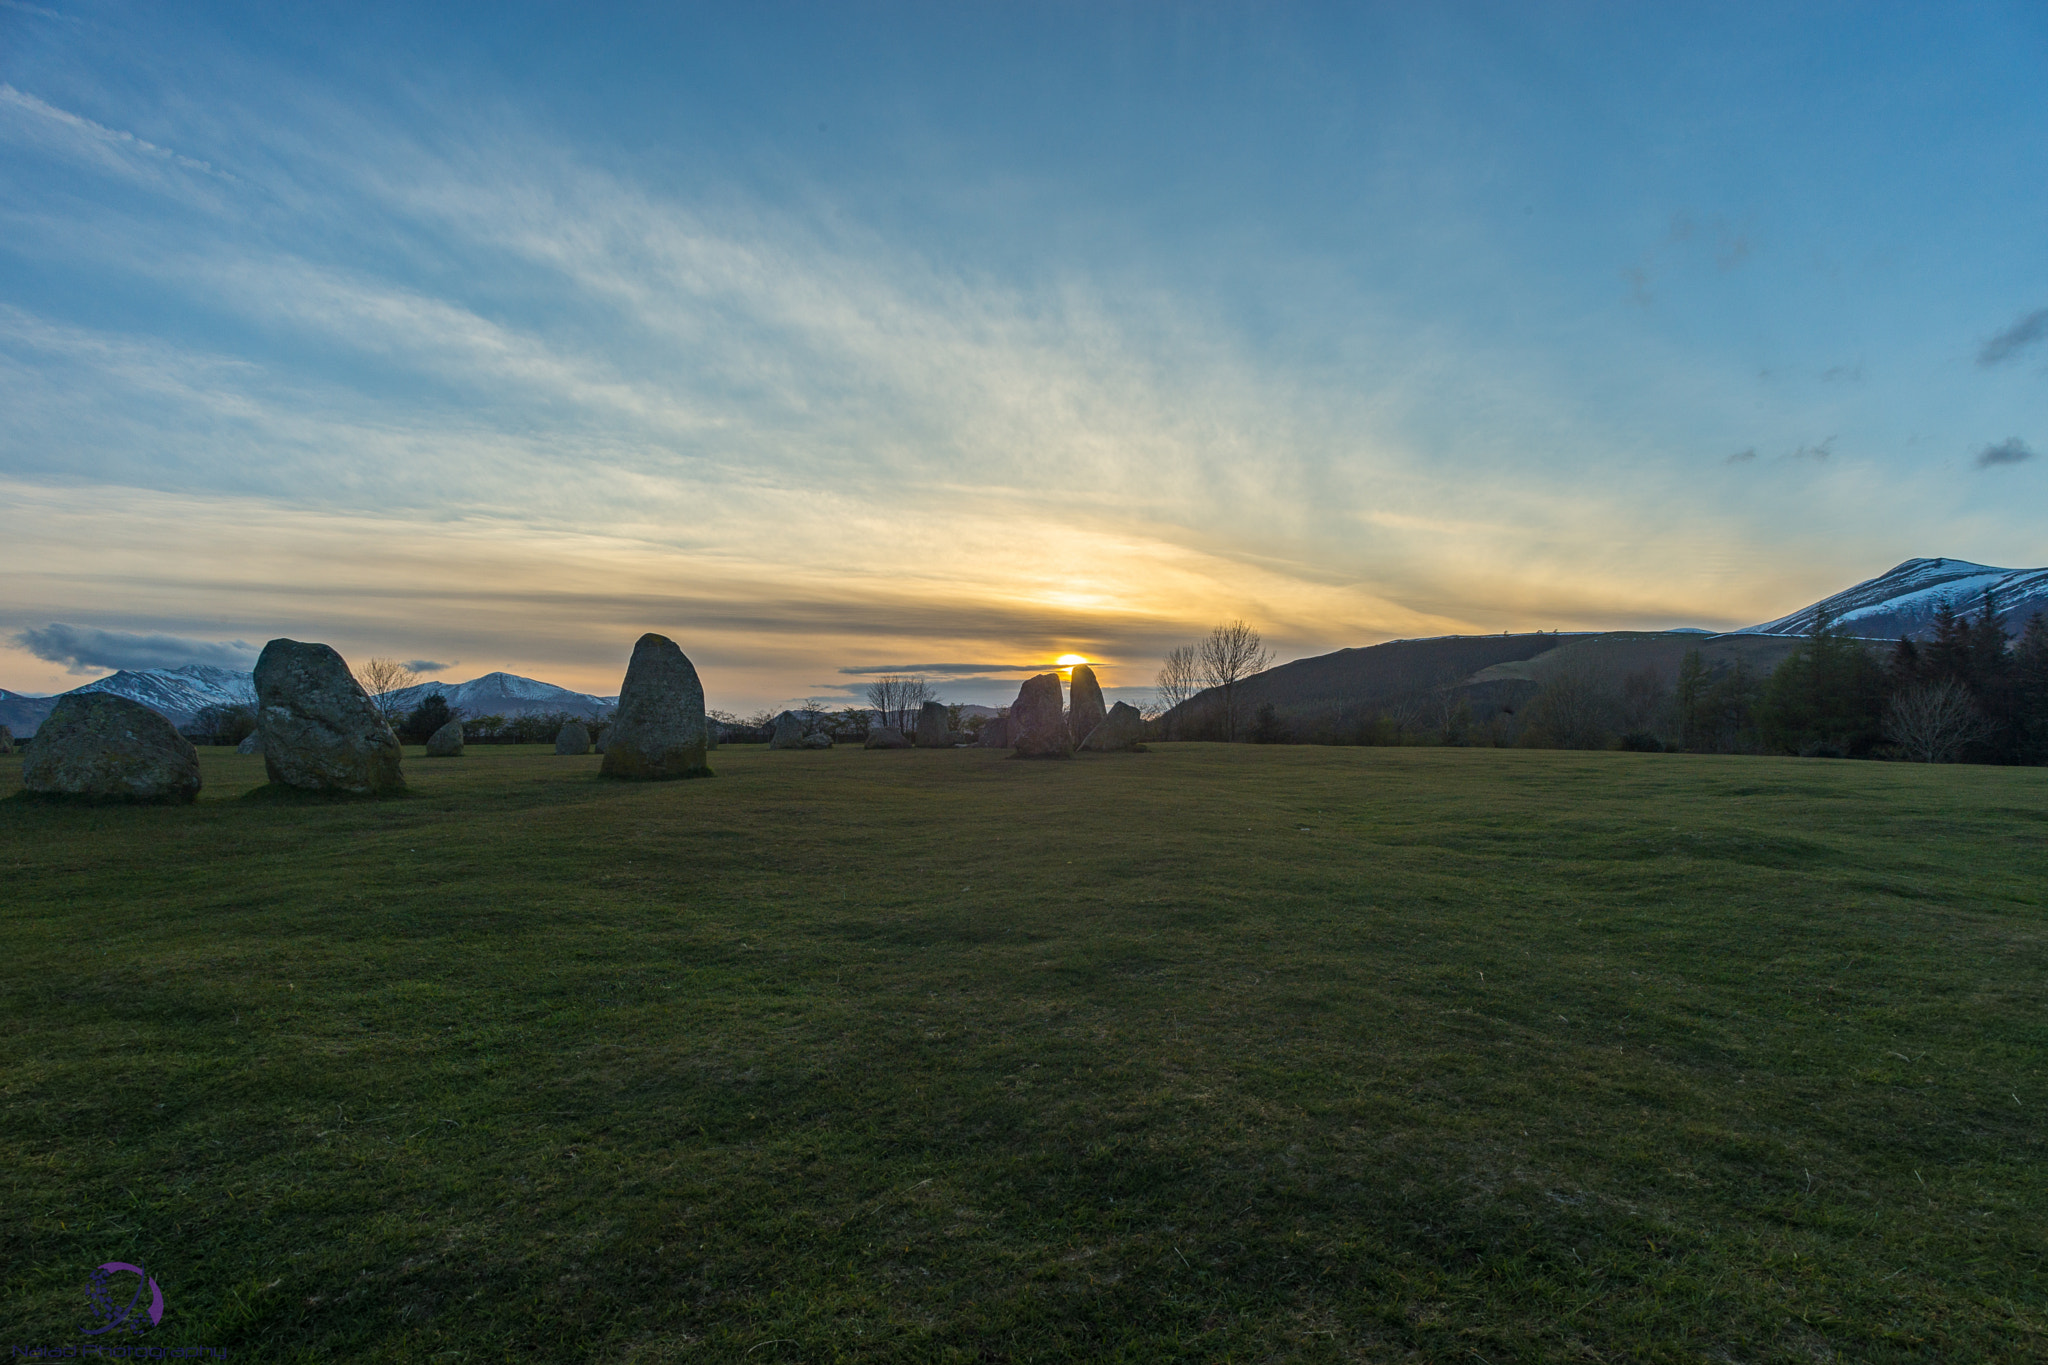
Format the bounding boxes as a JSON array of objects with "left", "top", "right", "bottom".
[{"left": 256, "top": 641, "right": 406, "bottom": 796}]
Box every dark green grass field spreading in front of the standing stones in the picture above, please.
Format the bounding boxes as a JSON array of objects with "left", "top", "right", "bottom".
[{"left": 0, "top": 745, "right": 2048, "bottom": 1363}]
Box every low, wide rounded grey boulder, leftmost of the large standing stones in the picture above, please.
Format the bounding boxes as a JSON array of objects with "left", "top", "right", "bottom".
[{"left": 20, "top": 692, "right": 199, "bottom": 802}]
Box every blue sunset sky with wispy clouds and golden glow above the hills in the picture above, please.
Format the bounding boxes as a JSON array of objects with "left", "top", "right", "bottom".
[{"left": 0, "top": 0, "right": 2048, "bottom": 712}]
